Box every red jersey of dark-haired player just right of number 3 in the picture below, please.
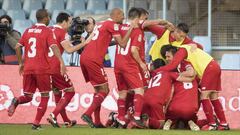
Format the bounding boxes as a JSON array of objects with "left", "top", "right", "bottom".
[{"left": 48, "top": 25, "right": 70, "bottom": 74}]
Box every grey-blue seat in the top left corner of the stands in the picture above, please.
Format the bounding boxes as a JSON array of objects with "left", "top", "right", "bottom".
[{"left": 2, "top": 0, "right": 22, "bottom": 11}]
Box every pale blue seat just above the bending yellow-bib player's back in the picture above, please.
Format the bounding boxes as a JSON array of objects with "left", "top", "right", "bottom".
[{"left": 193, "top": 36, "right": 212, "bottom": 54}]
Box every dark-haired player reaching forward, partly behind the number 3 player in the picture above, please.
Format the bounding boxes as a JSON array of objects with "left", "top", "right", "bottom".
[{"left": 47, "top": 13, "right": 89, "bottom": 127}]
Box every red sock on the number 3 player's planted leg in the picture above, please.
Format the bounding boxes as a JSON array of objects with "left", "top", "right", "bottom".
[{"left": 33, "top": 97, "right": 49, "bottom": 125}]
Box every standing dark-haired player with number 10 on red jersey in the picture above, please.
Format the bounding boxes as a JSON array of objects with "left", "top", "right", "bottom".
[{"left": 114, "top": 7, "right": 147, "bottom": 128}]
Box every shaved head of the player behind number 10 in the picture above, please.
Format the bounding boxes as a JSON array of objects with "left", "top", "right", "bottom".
[{"left": 110, "top": 8, "right": 124, "bottom": 23}]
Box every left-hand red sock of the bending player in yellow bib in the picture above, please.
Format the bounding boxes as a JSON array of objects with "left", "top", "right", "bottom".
[{"left": 202, "top": 99, "right": 215, "bottom": 124}]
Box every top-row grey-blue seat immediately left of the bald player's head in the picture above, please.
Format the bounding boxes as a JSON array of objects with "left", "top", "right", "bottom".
[{"left": 87, "top": 0, "right": 106, "bottom": 12}]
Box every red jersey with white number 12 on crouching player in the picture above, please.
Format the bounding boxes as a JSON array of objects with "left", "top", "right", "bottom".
[{"left": 145, "top": 71, "right": 178, "bottom": 104}]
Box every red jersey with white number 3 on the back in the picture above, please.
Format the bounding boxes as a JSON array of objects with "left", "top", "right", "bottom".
[{"left": 19, "top": 24, "right": 56, "bottom": 74}]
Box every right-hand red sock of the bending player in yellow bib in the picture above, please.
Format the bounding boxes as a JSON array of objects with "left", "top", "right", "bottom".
[{"left": 211, "top": 99, "right": 227, "bottom": 124}]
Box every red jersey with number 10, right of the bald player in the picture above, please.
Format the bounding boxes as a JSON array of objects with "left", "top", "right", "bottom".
[{"left": 114, "top": 24, "right": 143, "bottom": 71}]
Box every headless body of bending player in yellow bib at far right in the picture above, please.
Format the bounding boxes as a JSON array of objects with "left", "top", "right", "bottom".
[{"left": 155, "top": 45, "right": 229, "bottom": 130}]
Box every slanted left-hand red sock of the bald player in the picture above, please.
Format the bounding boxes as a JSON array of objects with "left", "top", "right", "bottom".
[{"left": 84, "top": 92, "right": 107, "bottom": 116}]
